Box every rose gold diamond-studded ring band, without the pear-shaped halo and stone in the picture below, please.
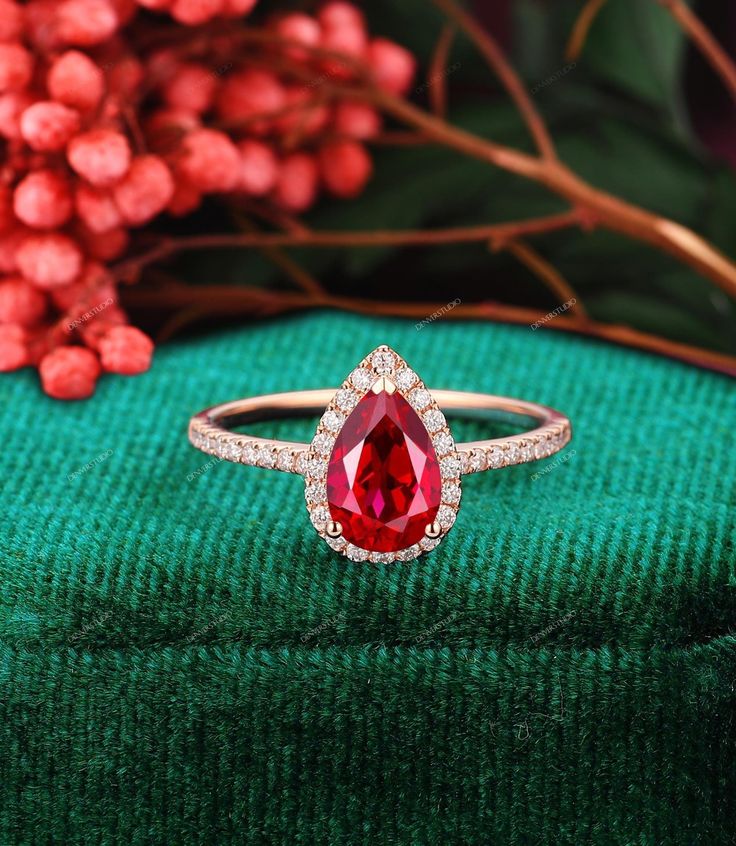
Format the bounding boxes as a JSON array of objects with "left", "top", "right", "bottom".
[{"left": 189, "top": 389, "right": 572, "bottom": 475}]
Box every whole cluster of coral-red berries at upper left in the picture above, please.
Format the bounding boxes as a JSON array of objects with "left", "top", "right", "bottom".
[{"left": 0, "top": 0, "right": 415, "bottom": 399}]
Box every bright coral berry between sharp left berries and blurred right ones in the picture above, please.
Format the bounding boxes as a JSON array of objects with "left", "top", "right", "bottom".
[{"left": 178, "top": 129, "right": 240, "bottom": 192}]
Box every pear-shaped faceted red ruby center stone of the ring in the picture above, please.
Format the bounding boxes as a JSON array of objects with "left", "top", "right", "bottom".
[{"left": 327, "top": 391, "right": 442, "bottom": 552}]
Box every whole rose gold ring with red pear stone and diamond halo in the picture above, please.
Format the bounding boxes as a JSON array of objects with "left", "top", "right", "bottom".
[{"left": 189, "top": 346, "right": 571, "bottom": 563}]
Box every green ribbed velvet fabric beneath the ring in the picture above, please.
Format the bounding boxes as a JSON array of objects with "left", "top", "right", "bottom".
[{"left": 0, "top": 314, "right": 736, "bottom": 846}]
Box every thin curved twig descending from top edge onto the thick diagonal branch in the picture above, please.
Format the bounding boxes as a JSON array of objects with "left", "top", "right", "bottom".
[{"left": 432, "top": 0, "right": 557, "bottom": 161}]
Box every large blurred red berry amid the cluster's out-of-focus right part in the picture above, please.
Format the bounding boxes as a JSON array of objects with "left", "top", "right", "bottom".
[{"left": 217, "top": 68, "right": 286, "bottom": 135}]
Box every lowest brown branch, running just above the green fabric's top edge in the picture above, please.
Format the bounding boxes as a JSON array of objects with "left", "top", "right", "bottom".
[{"left": 124, "top": 284, "right": 736, "bottom": 377}]
